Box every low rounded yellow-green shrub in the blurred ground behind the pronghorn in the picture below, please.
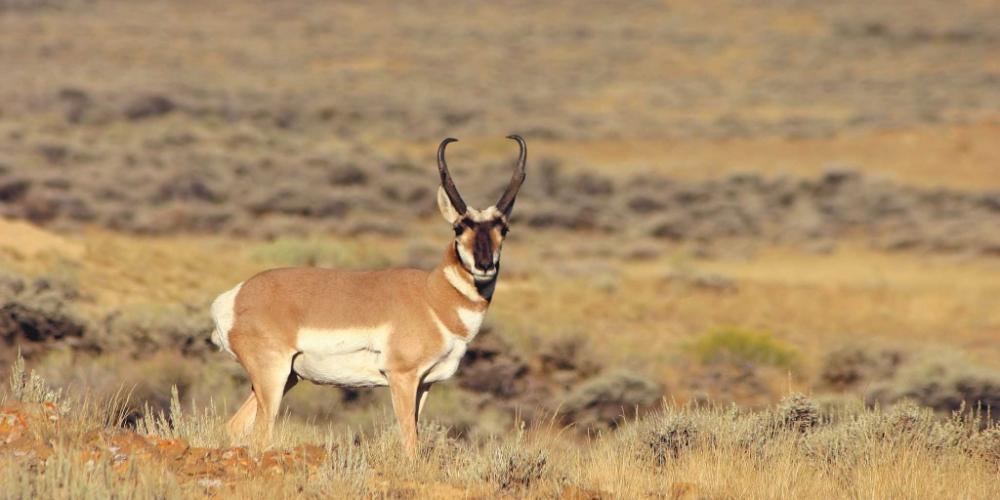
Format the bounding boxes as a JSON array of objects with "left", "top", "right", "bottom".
[{"left": 691, "top": 327, "right": 799, "bottom": 368}]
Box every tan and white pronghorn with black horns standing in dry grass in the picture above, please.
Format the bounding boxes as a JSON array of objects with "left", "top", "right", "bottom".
[{"left": 212, "top": 135, "right": 527, "bottom": 454}]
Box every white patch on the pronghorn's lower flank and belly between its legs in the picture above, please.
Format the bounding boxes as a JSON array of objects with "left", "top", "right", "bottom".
[{"left": 292, "top": 324, "right": 391, "bottom": 387}]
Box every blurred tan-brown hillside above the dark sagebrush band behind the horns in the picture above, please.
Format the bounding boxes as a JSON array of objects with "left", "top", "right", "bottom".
[{"left": 0, "top": 0, "right": 1000, "bottom": 188}]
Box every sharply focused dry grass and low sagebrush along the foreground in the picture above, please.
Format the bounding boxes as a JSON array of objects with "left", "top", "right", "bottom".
[{"left": 0, "top": 367, "right": 1000, "bottom": 498}]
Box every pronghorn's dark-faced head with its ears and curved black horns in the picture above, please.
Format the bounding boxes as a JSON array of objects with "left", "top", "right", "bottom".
[{"left": 438, "top": 135, "right": 528, "bottom": 282}]
